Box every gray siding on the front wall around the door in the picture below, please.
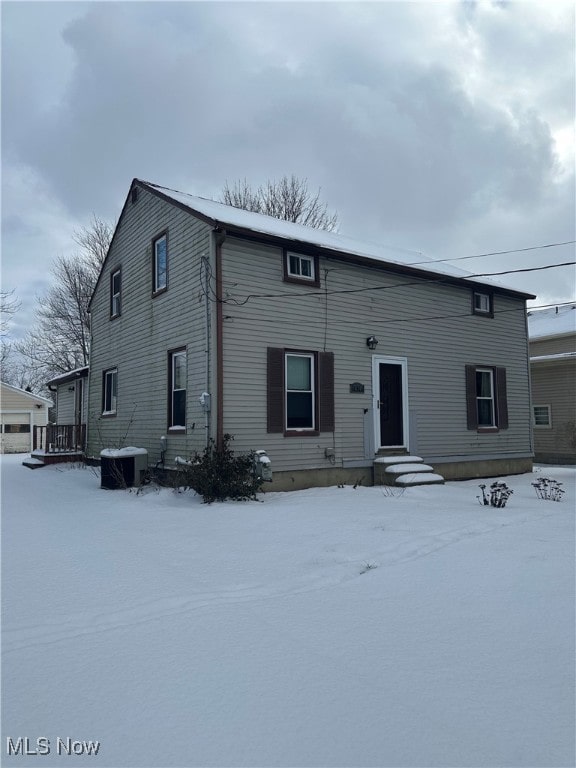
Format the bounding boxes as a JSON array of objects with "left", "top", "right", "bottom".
[{"left": 223, "top": 238, "right": 531, "bottom": 470}]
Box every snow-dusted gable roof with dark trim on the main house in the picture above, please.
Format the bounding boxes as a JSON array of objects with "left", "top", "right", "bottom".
[{"left": 90, "top": 179, "right": 536, "bottom": 303}]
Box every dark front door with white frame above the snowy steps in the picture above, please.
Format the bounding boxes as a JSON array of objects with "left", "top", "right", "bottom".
[{"left": 373, "top": 357, "right": 408, "bottom": 450}]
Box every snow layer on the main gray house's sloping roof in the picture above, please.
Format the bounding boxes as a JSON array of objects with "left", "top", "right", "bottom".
[{"left": 137, "top": 179, "right": 527, "bottom": 295}]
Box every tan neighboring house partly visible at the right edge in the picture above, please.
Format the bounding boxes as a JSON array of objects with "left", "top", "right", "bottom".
[{"left": 528, "top": 304, "right": 576, "bottom": 464}]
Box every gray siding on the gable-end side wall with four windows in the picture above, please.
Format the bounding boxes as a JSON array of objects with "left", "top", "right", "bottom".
[{"left": 88, "top": 189, "right": 213, "bottom": 463}]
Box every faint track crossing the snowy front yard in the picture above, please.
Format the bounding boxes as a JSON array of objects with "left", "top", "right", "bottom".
[{"left": 2, "top": 513, "right": 556, "bottom": 653}]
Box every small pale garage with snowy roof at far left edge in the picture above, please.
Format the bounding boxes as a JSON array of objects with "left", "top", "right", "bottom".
[{"left": 0, "top": 382, "right": 52, "bottom": 453}]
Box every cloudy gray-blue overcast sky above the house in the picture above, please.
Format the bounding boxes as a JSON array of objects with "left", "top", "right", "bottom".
[{"left": 2, "top": 0, "right": 576, "bottom": 336}]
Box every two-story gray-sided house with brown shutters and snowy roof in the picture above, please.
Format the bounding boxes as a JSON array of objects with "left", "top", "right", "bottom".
[{"left": 87, "top": 179, "right": 533, "bottom": 489}]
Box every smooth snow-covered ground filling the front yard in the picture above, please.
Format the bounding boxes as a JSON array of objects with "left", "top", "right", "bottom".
[{"left": 1, "top": 456, "right": 575, "bottom": 768}]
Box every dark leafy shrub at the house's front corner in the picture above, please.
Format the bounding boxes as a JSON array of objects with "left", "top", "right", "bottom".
[{"left": 176, "top": 435, "right": 262, "bottom": 504}]
